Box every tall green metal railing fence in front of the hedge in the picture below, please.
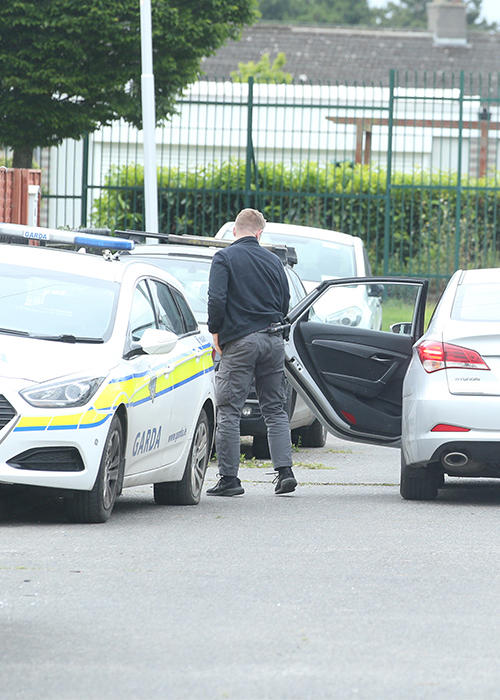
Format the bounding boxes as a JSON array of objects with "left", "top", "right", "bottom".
[{"left": 42, "top": 71, "right": 500, "bottom": 288}]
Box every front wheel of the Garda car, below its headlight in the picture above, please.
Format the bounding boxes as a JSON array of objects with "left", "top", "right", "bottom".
[{"left": 66, "top": 415, "right": 124, "bottom": 523}]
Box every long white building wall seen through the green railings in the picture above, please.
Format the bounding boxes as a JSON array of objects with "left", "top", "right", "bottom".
[{"left": 44, "top": 82, "right": 500, "bottom": 226}]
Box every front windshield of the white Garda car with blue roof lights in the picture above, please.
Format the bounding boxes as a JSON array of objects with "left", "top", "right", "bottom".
[{"left": 0, "top": 263, "right": 118, "bottom": 343}]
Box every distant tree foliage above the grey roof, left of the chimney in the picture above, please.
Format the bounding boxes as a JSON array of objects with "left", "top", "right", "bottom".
[{"left": 259, "top": 0, "right": 372, "bottom": 24}]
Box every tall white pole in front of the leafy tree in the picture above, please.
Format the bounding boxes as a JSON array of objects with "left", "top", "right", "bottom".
[{"left": 140, "top": 0, "right": 158, "bottom": 235}]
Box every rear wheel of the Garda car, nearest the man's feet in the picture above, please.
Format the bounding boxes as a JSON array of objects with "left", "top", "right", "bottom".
[{"left": 153, "top": 410, "right": 207, "bottom": 506}]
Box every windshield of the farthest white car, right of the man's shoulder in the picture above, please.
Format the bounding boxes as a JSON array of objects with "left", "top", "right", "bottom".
[{"left": 260, "top": 231, "right": 356, "bottom": 282}]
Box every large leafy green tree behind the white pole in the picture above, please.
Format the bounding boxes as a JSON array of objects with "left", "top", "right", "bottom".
[{"left": 0, "top": 0, "right": 258, "bottom": 167}]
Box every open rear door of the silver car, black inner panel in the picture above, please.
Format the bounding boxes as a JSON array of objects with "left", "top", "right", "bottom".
[{"left": 285, "top": 277, "right": 428, "bottom": 446}]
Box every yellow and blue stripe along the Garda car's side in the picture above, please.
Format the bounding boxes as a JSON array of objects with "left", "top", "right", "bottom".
[{"left": 14, "top": 343, "right": 214, "bottom": 432}]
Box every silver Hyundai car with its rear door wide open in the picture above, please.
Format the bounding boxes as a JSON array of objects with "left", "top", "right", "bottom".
[{"left": 286, "top": 268, "right": 500, "bottom": 500}]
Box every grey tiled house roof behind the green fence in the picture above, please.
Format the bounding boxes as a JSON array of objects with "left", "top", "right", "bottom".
[{"left": 201, "top": 22, "right": 500, "bottom": 96}]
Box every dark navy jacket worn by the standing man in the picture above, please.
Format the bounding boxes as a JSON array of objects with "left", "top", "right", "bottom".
[{"left": 208, "top": 236, "right": 290, "bottom": 346}]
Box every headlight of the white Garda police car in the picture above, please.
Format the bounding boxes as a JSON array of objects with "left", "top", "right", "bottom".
[{"left": 19, "top": 377, "right": 104, "bottom": 408}]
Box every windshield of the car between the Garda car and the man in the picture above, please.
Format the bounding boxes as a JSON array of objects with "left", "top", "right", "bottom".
[{"left": 134, "top": 255, "right": 212, "bottom": 324}]
